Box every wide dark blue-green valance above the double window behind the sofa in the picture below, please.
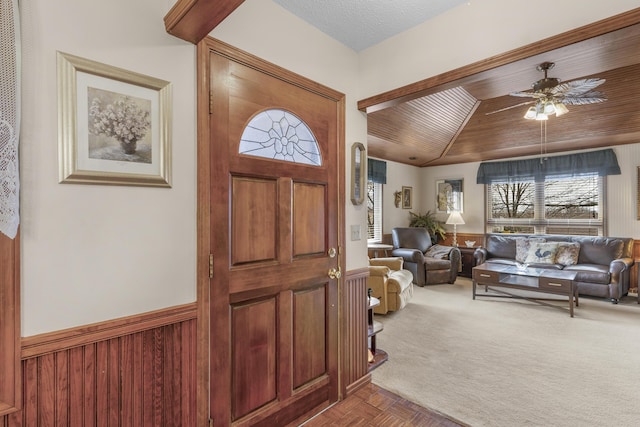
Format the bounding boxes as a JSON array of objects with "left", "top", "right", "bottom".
[{"left": 476, "top": 148, "right": 621, "bottom": 184}]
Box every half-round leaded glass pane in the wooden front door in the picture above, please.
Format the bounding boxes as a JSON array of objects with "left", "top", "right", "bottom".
[{"left": 238, "top": 109, "right": 322, "bottom": 166}]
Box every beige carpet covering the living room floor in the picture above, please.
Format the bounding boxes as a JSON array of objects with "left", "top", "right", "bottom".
[{"left": 372, "top": 278, "right": 640, "bottom": 427}]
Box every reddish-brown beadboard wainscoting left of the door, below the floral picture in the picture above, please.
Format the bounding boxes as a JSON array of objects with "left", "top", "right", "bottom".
[{"left": 0, "top": 303, "right": 196, "bottom": 427}]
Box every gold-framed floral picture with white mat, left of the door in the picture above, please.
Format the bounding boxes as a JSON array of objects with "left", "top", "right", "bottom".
[{"left": 57, "top": 52, "right": 172, "bottom": 187}]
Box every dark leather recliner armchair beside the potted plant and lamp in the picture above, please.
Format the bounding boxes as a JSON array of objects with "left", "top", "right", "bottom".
[{"left": 391, "top": 227, "right": 461, "bottom": 286}]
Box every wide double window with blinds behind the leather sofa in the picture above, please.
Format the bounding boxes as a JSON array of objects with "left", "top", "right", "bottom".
[{"left": 486, "top": 173, "right": 606, "bottom": 236}]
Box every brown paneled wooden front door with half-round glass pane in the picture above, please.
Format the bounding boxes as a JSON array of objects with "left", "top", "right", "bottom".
[{"left": 208, "top": 41, "right": 343, "bottom": 426}]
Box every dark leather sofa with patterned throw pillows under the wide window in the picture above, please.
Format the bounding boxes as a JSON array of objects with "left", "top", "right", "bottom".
[{"left": 474, "top": 233, "right": 634, "bottom": 304}]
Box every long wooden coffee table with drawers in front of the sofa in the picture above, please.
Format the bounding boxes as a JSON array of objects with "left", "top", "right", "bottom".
[{"left": 472, "top": 263, "right": 579, "bottom": 317}]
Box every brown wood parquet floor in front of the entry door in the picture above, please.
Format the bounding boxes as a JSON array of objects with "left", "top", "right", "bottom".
[{"left": 304, "top": 384, "right": 466, "bottom": 427}]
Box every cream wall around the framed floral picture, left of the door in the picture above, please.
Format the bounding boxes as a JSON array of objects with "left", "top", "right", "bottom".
[{"left": 20, "top": 0, "right": 196, "bottom": 336}]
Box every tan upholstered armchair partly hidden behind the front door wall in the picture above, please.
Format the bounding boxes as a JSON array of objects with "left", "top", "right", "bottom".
[{"left": 367, "top": 257, "right": 413, "bottom": 314}]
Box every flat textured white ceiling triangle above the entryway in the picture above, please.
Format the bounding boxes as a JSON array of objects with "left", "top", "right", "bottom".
[{"left": 273, "top": 0, "right": 471, "bottom": 52}]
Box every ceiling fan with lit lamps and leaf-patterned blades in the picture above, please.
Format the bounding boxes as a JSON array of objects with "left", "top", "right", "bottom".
[{"left": 486, "top": 62, "right": 607, "bottom": 120}]
